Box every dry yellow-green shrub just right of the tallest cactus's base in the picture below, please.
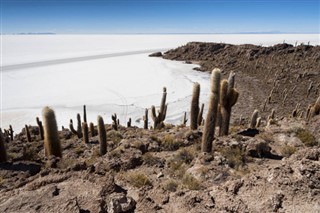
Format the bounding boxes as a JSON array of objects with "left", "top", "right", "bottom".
[{"left": 218, "top": 147, "right": 247, "bottom": 170}]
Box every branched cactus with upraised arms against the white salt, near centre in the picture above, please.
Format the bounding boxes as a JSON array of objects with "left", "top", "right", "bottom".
[{"left": 151, "top": 87, "right": 168, "bottom": 129}]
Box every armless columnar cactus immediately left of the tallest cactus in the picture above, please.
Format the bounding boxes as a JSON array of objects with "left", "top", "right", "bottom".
[{"left": 190, "top": 83, "right": 200, "bottom": 130}]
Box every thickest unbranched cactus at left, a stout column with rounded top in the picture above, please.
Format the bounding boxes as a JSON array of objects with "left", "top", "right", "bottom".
[{"left": 42, "top": 107, "right": 62, "bottom": 157}]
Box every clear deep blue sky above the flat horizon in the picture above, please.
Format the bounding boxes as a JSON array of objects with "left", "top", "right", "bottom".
[{"left": 1, "top": 0, "right": 320, "bottom": 34}]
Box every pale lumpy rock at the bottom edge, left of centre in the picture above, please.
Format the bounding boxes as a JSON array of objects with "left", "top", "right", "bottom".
[{"left": 108, "top": 193, "right": 136, "bottom": 213}]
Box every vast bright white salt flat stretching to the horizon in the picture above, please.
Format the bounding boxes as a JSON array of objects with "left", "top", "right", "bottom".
[{"left": 1, "top": 34, "right": 320, "bottom": 130}]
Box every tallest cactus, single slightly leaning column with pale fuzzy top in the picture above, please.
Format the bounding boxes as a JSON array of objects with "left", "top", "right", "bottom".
[{"left": 201, "top": 68, "right": 221, "bottom": 153}]
